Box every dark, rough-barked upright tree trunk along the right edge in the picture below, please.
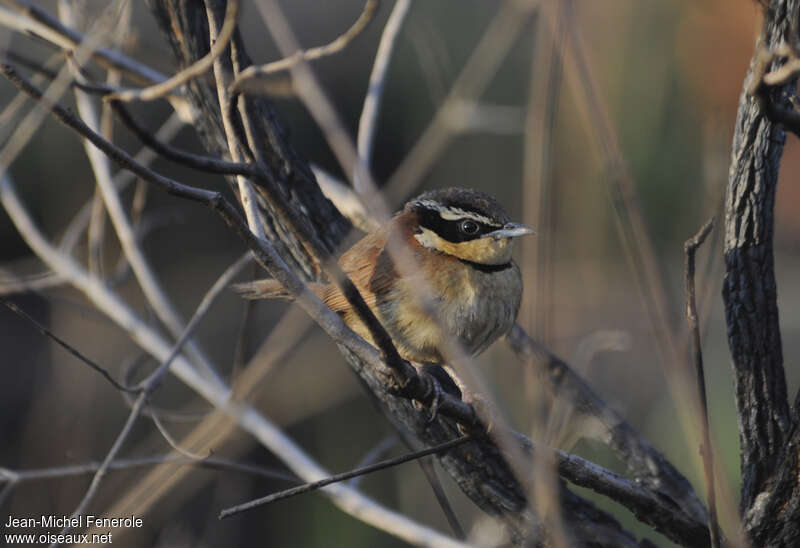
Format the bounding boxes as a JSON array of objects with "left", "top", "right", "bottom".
[{"left": 723, "top": 0, "right": 800, "bottom": 546}]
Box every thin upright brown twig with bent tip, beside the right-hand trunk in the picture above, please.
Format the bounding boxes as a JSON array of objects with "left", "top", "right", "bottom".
[{"left": 683, "top": 217, "right": 722, "bottom": 548}]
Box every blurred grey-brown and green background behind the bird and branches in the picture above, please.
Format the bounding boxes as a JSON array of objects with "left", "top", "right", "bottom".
[{"left": 0, "top": 0, "right": 800, "bottom": 546}]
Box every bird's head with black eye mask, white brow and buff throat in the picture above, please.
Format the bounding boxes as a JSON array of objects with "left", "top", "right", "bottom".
[{"left": 404, "top": 188, "right": 534, "bottom": 265}]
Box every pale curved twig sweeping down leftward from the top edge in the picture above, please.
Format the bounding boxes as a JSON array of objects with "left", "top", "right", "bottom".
[{"left": 105, "top": 0, "right": 240, "bottom": 102}]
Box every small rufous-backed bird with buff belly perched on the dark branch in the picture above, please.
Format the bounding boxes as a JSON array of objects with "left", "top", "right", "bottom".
[{"left": 234, "top": 187, "right": 534, "bottom": 366}]
